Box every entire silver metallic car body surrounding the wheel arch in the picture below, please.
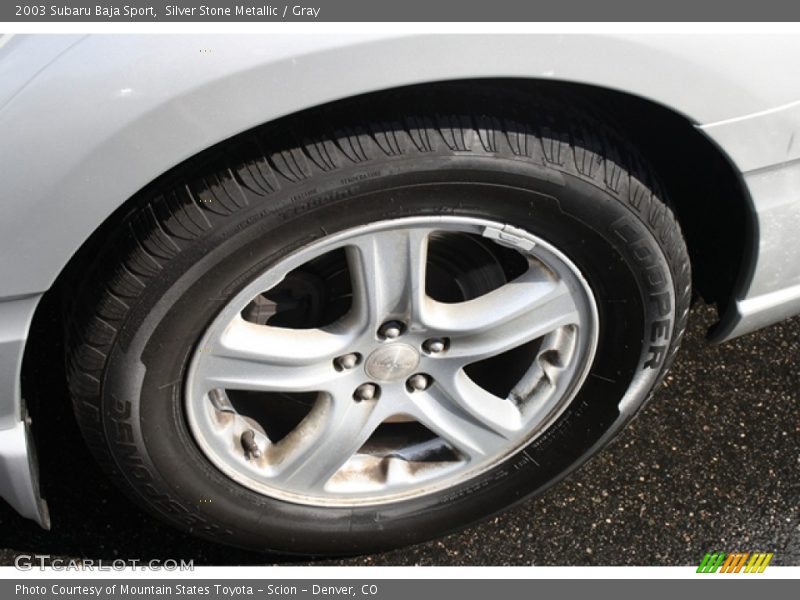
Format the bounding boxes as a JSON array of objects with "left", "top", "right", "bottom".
[{"left": 0, "top": 34, "right": 800, "bottom": 527}]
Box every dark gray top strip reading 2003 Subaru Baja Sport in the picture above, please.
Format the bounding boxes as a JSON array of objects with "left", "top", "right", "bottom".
[{"left": 0, "top": 0, "right": 800, "bottom": 23}]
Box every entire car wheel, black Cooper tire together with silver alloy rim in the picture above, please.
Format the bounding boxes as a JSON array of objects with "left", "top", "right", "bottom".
[{"left": 69, "top": 92, "right": 690, "bottom": 554}]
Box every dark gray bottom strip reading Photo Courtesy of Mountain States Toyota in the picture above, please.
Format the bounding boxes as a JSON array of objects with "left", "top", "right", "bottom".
[{"left": 6, "top": 575, "right": 797, "bottom": 600}]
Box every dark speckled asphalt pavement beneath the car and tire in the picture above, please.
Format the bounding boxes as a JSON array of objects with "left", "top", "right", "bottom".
[{"left": 0, "top": 306, "right": 800, "bottom": 565}]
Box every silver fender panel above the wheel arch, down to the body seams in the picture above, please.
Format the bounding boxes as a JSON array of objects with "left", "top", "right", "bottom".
[{"left": 0, "top": 35, "right": 800, "bottom": 298}]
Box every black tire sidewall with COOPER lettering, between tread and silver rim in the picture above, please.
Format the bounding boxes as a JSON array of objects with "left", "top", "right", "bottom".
[{"left": 97, "top": 156, "right": 676, "bottom": 554}]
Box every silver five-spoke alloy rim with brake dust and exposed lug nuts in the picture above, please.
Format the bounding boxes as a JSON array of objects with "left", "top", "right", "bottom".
[{"left": 186, "top": 217, "right": 597, "bottom": 505}]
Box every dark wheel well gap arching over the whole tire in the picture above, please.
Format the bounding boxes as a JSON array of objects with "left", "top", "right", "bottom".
[{"left": 31, "top": 79, "right": 754, "bottom": 354}]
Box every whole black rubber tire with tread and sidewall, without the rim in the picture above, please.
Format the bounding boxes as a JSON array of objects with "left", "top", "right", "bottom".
[{"left": 68, "top": 88, "right": 690, "bottom": 554}]
